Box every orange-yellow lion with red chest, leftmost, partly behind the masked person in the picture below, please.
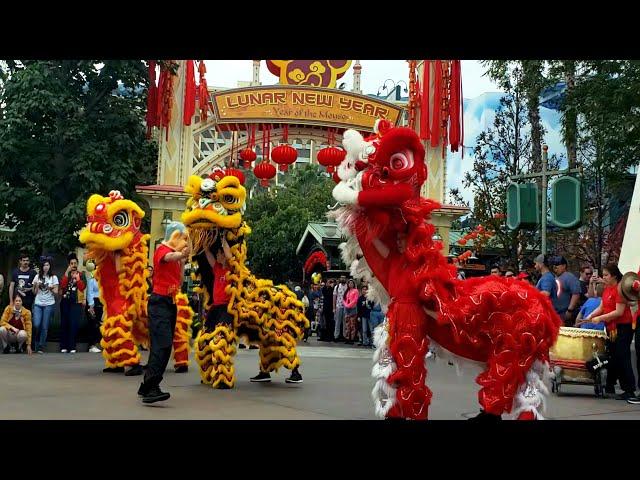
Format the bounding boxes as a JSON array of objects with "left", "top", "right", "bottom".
[{"left": 80, "top": 191, "right": 192, "bottom": 375}]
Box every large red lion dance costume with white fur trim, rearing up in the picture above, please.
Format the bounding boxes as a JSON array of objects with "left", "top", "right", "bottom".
[{"left": 333, "top": 120, "right": 561, "bottom": 420}]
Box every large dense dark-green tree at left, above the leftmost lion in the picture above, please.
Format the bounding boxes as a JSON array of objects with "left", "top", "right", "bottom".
[{"left": 0, "top": 60, "right": 157, "bottom": 254}]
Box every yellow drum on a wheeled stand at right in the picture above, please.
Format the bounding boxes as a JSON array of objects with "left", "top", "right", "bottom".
[{"left": 549, "top": 327, "right": 607, "bottom": 382}]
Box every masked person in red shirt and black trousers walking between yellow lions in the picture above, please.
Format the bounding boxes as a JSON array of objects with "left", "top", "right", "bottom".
[{"left": 138, "top": 222, "right": 191, "bottom": 403}]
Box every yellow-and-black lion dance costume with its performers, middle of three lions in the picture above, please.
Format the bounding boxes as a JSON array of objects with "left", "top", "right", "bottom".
[{"left": 182, "top": 169, "right": 309, "bottom": 388}]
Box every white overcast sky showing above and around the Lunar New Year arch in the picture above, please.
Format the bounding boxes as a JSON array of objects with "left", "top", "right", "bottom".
[{"left": 205, "top": 60, "right": 500, "bottom": 98}]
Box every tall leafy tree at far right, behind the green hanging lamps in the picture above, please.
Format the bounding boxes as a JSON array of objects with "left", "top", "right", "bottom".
[{"left": 549, "top": 60, "right": 640, "bottom": 268}]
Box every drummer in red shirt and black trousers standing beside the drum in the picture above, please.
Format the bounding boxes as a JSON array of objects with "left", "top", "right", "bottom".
[{"left": 587, "top": 263, "right": 636, "bottom": 400}]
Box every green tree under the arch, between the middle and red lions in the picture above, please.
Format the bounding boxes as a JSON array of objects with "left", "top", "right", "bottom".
[{"left": 245, "top": 165, "right": 335, "bottom": 283}]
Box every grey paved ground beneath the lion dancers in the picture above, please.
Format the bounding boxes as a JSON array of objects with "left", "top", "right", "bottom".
[{"left": 0, "top": 339, "right": 640, "bottom": 420}]
